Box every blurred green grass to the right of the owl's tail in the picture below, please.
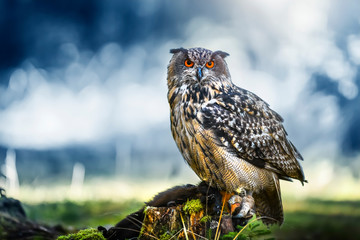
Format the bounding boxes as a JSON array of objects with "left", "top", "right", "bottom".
[{"left": 274, "top": 199, "right": 360, "bottom": 239}]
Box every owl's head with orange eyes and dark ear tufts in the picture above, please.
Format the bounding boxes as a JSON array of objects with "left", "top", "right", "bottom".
[{"left": 168, "top": 48, "right": 231, "bottom": 89}]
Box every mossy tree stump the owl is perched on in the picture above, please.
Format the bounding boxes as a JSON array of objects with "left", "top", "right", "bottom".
[{"left": 99, "top": 183, "right": 248, "bottom": 240}]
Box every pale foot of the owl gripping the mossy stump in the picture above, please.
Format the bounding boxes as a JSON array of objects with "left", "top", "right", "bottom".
[{"left": 228, "top": 194, "right": 255, "bottom": 226}]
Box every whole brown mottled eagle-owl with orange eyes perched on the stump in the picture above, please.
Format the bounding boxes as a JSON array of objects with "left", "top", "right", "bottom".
[{"left": 167, "top": 48, "right": 306, "bottom": 225}]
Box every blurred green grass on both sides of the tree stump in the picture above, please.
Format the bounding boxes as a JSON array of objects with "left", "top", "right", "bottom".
[{"left": 21, "top": 199, "right": 360, "bottom": 239}]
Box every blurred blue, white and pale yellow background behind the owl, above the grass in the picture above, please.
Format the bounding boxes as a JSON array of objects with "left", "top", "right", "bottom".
[{"left": 0, "top": 0, "right": 360, "bottom": 238}]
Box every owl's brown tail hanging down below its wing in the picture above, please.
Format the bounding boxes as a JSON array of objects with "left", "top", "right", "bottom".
[{"left": 253, "top": 173, "right": 284, "bottom": 226}]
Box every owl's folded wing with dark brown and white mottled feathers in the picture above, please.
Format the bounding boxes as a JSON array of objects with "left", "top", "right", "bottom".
[{"left": 197, "top": 88, "right": 305, "bottom": 182}]
